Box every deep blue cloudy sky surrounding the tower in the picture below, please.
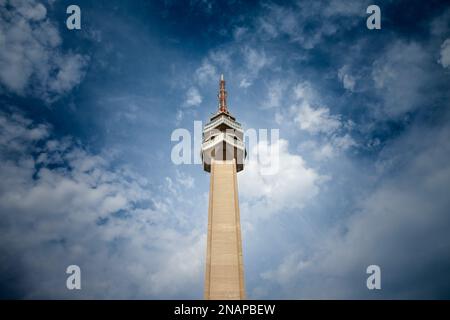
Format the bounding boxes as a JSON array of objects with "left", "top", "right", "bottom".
[{"left": 0, "top": 0, "right": 450, "bottom": 299}]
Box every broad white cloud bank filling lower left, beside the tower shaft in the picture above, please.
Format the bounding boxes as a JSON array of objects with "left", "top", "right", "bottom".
[{"left": 0, "top": 113, "right": 207, "bottom": 299}]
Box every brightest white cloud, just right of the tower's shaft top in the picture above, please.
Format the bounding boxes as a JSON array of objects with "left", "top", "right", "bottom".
[{"left": 239, "top": 139, "right": 325, "bottom": 220}]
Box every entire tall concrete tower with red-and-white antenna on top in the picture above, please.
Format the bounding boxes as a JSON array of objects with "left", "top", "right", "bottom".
[{"left": 201, "top": 75, "right": 246, "bottom": 300}]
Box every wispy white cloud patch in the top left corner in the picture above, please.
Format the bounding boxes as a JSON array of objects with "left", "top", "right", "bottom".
[{"left": 0, "top": 1, "right": 88, "bottom": 102}]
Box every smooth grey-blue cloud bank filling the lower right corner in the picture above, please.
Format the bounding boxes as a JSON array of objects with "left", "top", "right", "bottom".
[{"left": 261, "top": 121, "right": 450, "bottom": 299}]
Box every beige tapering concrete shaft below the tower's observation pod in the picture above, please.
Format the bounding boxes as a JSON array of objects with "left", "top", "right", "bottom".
[{"left": 204, "top": 159, "right": 245, "bottom": 300}]
